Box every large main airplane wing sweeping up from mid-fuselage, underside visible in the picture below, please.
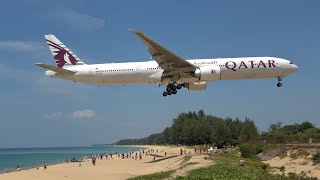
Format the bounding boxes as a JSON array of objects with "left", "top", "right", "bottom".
[{"left": 129, "top": 29, "right": 196, "bottom": 73}]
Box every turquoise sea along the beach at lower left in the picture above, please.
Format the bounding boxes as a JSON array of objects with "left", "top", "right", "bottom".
[{"left": 0, "top": 145, "right": 142, "bottom": 173}]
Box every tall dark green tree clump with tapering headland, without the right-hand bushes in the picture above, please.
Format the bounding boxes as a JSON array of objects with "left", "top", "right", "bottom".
[{"left": 116, "top": 110, "right": 259, "bottom": 147}]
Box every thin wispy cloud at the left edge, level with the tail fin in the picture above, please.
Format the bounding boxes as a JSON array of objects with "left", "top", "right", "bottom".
[{"left": 0, "top": 40, "right": 45, "bottom": 52}]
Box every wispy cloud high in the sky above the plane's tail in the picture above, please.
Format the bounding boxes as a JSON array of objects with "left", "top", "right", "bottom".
[{"left": 55, "top": 9, "right": 105, "bottom": 31}]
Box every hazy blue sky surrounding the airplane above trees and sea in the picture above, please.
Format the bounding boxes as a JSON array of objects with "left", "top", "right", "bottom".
[{"left": 0, "top": 0, "right": 320, "bottom": 147}]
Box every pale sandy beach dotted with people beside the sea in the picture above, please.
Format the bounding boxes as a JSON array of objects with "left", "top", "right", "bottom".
[{"left": 0, "top": 146, "right": 212, "bottom": 180}]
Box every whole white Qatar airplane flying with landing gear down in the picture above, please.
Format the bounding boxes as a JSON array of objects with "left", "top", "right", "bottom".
[{"left": 36, "top": 30, "right": 298, "bottom": 96}]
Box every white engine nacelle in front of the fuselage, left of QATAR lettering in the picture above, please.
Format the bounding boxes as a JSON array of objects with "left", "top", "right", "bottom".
[{"left": 194, "top": 65, "right": 221, "bottom": 81}]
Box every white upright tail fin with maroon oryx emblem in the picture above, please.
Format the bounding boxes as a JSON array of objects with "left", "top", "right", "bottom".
[{"left": 44, "top": 34, "right": 85, "bottom": 68}]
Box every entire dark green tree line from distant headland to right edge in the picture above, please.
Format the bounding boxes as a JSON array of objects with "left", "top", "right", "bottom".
[{"left": 115, "top": 110, "right": 320, "bottom": 147}]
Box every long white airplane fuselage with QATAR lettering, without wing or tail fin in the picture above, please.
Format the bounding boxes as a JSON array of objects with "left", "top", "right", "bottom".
[{"left": 46, "top": 57, "right": 298, "bottom": 85}]
